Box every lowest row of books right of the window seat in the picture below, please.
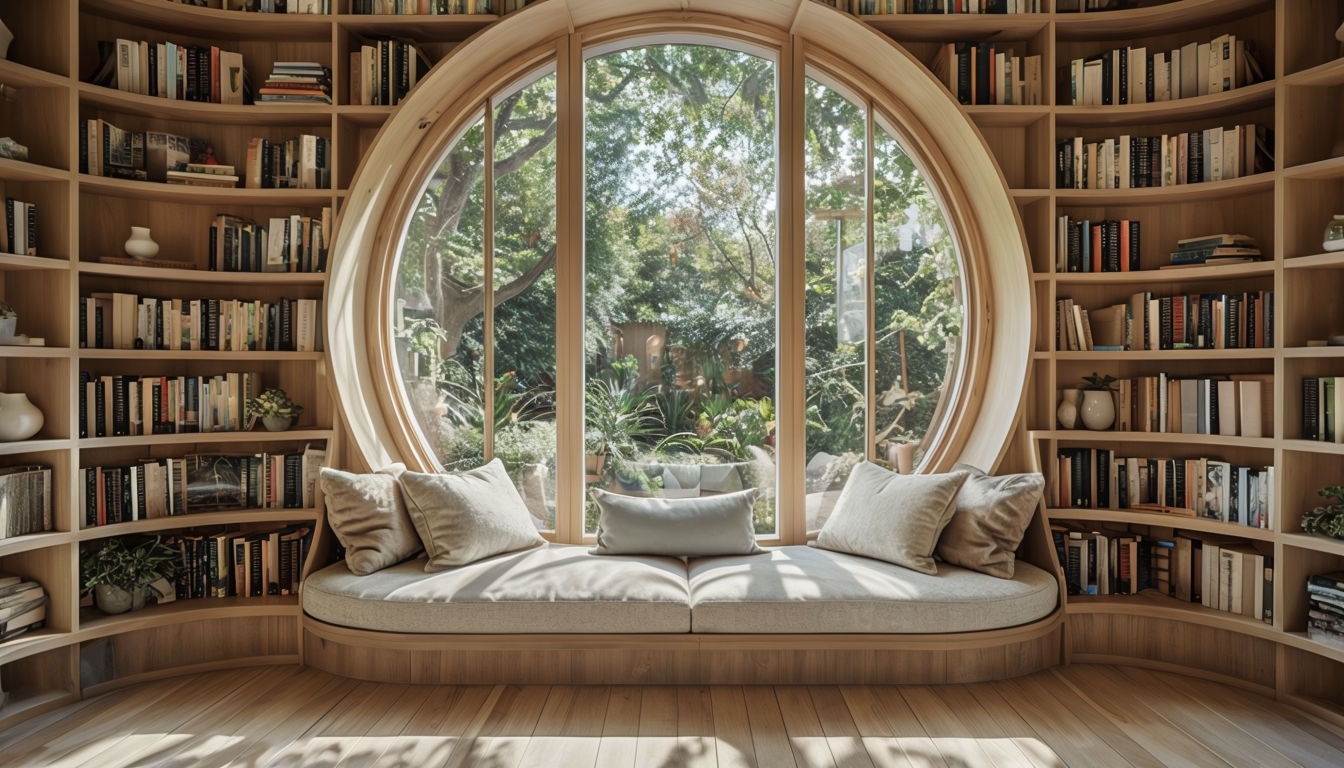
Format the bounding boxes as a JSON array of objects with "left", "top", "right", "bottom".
[{"left": 1051, "top": 523, "right": 1274, "bottom": 624}]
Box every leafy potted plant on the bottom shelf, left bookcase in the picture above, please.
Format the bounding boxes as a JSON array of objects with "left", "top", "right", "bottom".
[{"left": 79, "top": 537, "right": 181, "bottom": 613}]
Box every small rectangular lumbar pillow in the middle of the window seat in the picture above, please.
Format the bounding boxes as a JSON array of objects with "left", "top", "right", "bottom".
[{"left": 591, "top": 488, "right": 762, "bottom": 557}]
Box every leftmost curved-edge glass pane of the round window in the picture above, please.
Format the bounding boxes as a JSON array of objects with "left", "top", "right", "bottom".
[{"left": 392, "top": 114, "right": 488, "bottom": 469}]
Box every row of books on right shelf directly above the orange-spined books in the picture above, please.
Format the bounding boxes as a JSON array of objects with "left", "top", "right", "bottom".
[{"left": 1055, "top": 124, "right": 1274, "bottom": 190}]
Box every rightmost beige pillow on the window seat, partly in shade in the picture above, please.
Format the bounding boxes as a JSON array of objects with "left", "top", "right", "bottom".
[{"left": 935, "top": 464, "right": 1046, "bottom": 578}]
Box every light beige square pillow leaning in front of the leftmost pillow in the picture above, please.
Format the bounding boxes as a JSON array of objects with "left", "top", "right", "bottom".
[{"left": 398, "top": 459, "right": 546, "bottom": 570}]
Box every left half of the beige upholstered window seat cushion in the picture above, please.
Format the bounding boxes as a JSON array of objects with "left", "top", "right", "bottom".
[{"left": 301, "top": 543, "right": 691, "bottom": 633}]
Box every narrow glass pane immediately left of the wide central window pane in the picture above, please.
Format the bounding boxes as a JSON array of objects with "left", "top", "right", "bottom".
[{"left": 493, "top": 75, "right": 555, "bottom": 530}]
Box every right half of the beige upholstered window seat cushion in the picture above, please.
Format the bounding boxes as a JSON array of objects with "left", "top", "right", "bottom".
[{"left": 689, "top": 546, "right": 1059, "bottom": 633}]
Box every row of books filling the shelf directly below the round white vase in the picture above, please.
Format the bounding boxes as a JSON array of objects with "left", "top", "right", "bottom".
[{"left": 79, "top": 292, "right": 321, "bottom": 352}]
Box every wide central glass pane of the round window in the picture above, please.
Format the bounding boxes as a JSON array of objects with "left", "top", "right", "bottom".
[{"left": 585, "top": 44, "right": 778, "bottom": 535}]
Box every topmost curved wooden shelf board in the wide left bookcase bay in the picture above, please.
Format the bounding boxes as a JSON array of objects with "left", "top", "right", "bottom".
[{"left": 79, "top": 0, "right": 332, "bottom": 43}]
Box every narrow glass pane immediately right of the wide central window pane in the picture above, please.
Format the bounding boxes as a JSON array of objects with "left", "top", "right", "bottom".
[{"left": 804, "top": 79, "right": 871, "bottom": 530}]
